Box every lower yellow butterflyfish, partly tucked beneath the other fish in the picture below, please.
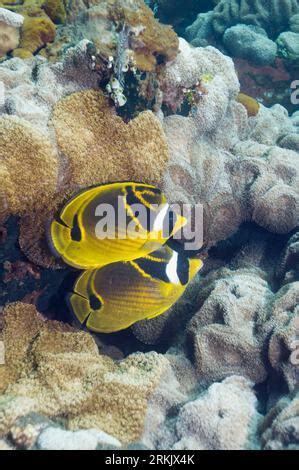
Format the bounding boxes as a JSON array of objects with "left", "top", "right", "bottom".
[{"left": 67, "top": 244, "right": 203, "bottom": 333}]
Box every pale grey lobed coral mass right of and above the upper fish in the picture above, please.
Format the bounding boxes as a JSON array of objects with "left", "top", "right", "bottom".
[{"left": 163, "top": 40, "right": 299, "bottom": 244}]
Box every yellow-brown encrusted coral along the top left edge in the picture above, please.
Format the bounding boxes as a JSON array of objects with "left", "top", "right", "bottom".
[{"left": 0, "top": 0, "right": 178, "bottom": 71}]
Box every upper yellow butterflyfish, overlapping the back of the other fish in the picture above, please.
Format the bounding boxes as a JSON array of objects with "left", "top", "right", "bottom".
[{"left": 49, "top": 182, "right": 186, "bottom": 269}]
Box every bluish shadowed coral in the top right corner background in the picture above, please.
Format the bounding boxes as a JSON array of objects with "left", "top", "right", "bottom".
[{"left": 186, "top": 0, "right": 299, "bottom": 66}]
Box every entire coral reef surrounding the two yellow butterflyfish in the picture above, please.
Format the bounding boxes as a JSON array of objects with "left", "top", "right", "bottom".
[{"left": 0, "top": 10, "right": 299, "bottom": 450}]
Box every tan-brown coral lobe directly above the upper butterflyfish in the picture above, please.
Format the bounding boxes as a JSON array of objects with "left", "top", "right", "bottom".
[{"left": 51, "top": 90, "right": 168, "bottom": 185}]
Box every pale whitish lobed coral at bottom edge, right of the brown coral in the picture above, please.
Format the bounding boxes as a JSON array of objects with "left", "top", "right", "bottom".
[{"left": 139, "top": 366, "right": 261, "bottom": 450}]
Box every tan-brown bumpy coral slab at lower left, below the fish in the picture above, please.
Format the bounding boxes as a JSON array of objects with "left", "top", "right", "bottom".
[{"left": 0, "top": 303, "right": 166, "bottom": 442}]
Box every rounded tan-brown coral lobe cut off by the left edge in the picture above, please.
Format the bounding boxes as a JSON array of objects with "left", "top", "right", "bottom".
[{"left": 0, "top": 116, "right": 58, "bottom": 215}]
